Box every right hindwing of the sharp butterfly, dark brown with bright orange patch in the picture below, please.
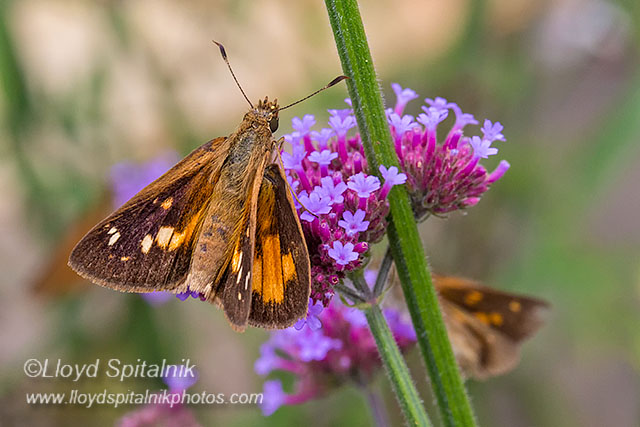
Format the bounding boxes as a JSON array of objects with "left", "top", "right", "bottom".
[{"left": 249, "top": 164, "right": 311, "bottom": 328}]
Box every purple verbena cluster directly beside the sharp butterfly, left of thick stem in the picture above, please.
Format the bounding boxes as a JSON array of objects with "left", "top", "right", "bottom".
[{"left": 282, "top": 112, "right": 406, "bottom": 305}]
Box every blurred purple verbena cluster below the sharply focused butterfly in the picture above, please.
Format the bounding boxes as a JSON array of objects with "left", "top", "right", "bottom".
[{"left": 255, "top": 282, "right": 416, "bottom": 415}]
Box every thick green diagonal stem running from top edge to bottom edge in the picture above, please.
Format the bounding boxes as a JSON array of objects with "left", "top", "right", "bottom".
[{"left": 325, "top": 0, "right": 475, "bottom": 426}]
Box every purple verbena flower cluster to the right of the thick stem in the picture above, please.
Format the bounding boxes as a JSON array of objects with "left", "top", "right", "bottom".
[{"left": 387, "top": 83, "right": 509, "bottom": 219}]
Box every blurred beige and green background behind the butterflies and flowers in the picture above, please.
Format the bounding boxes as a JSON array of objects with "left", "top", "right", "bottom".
[{"left": 0, "top": 0, "right": 640, "bottom": 426}]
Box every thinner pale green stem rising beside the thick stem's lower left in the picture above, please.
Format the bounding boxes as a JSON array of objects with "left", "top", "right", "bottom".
[{"left": 349, "top": 270, "right": 431, "bottom": 426}]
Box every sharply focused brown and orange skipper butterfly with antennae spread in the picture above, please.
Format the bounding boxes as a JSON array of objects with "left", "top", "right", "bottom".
[{"left": 69, "top": 42, "right": 346, "bottom": 331}]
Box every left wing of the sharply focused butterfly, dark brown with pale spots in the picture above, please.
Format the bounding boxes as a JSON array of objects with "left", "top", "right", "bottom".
[{"left": 69, "top": 138, "right": 228, "bottom": 292}]
